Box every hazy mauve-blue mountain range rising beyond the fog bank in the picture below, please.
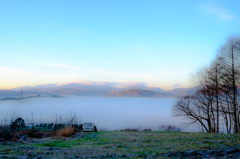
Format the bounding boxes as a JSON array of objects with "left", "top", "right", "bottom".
[{"left": 0, "top": 82, "right": 195, "bottom": 98}]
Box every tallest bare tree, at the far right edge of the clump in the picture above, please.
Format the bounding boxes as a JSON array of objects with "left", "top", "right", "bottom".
[{"left": 218, "top": 37, "right": 240, "bottom": 133}]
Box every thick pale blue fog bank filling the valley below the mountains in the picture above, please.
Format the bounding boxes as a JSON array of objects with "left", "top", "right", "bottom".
[{"left": 0, "top": 96, "right": 199, "bottom": 131}]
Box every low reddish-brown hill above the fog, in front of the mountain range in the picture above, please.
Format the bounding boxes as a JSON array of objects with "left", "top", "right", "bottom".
[{"left": 106, "top": 89, "right": 174, "bottom": 98}]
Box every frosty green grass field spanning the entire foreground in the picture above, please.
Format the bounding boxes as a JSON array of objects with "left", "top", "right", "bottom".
[{"left": 0, "top": 131, "right": 240, "bottom": 158}]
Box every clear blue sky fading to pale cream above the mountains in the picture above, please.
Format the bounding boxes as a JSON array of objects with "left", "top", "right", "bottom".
[{"left": 0, "top": 0, "right": 240, "bottom": 89}]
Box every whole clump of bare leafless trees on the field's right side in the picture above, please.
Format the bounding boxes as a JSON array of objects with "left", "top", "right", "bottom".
[{"left": 173, "top": 36, "right": 240, "bottom": 133}]
